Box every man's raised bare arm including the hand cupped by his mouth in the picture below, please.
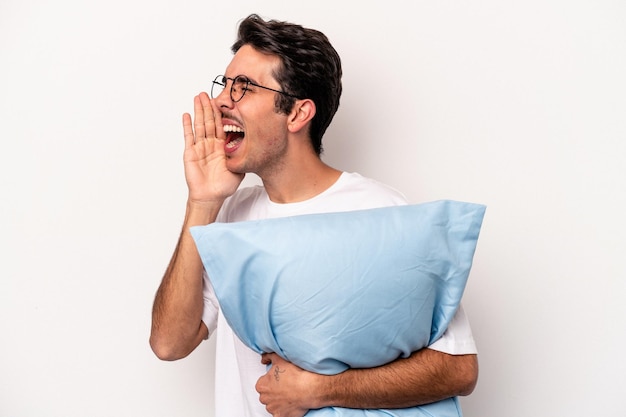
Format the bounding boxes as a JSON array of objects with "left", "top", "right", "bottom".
[{"left": 150, "top": 93, "right": 243, "bottom": 360}]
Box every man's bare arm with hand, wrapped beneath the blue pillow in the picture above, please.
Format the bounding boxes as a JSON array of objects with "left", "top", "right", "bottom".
[{"left": 257, "top": 348, "right": 478, "bottom": 417}]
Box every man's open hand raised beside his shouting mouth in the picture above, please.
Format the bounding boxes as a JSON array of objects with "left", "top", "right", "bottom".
[{"left": 183, "top": 93, "right": 245, "bottom": 203}]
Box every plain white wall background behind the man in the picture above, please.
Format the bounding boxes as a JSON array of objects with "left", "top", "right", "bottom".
[{"left": 0, "top": 0, "right": 626, "bottom": 417}]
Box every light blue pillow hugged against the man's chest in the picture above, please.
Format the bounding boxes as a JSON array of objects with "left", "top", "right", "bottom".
[{"left": 191, "top": 200, "right": 485, "bottom": 415}]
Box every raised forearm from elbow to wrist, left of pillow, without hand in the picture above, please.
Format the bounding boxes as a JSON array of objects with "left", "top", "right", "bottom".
[{"left": 150, "top": 198, "right": 219, "bottom": 360}]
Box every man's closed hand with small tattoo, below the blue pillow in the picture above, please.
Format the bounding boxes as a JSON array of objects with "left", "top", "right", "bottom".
[{"left": 256, "top": 353, "right": 322, "bottom": 417}]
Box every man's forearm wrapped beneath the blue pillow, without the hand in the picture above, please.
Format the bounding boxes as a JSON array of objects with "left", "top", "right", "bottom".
[{"left": 315, "top": 349, "right": 478, "bottom": 408}]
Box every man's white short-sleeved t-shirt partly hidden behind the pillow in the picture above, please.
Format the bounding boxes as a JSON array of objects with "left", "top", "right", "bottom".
[{"left": 202, "top": 172, "right": 477, "bottom": 417}]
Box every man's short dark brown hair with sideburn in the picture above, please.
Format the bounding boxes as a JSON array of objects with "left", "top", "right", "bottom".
[{"left": 231, "top": 14, "right": 342, "bottom": 155}]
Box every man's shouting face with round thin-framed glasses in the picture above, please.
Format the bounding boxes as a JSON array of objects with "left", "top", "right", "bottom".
[{"left": 215, "top": 45, "right": 288, "bottom": 178}]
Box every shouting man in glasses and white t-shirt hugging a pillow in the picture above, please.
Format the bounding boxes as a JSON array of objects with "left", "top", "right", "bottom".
[{"left": 150, "top": 15, "right": 478, "bottom": 417}]
